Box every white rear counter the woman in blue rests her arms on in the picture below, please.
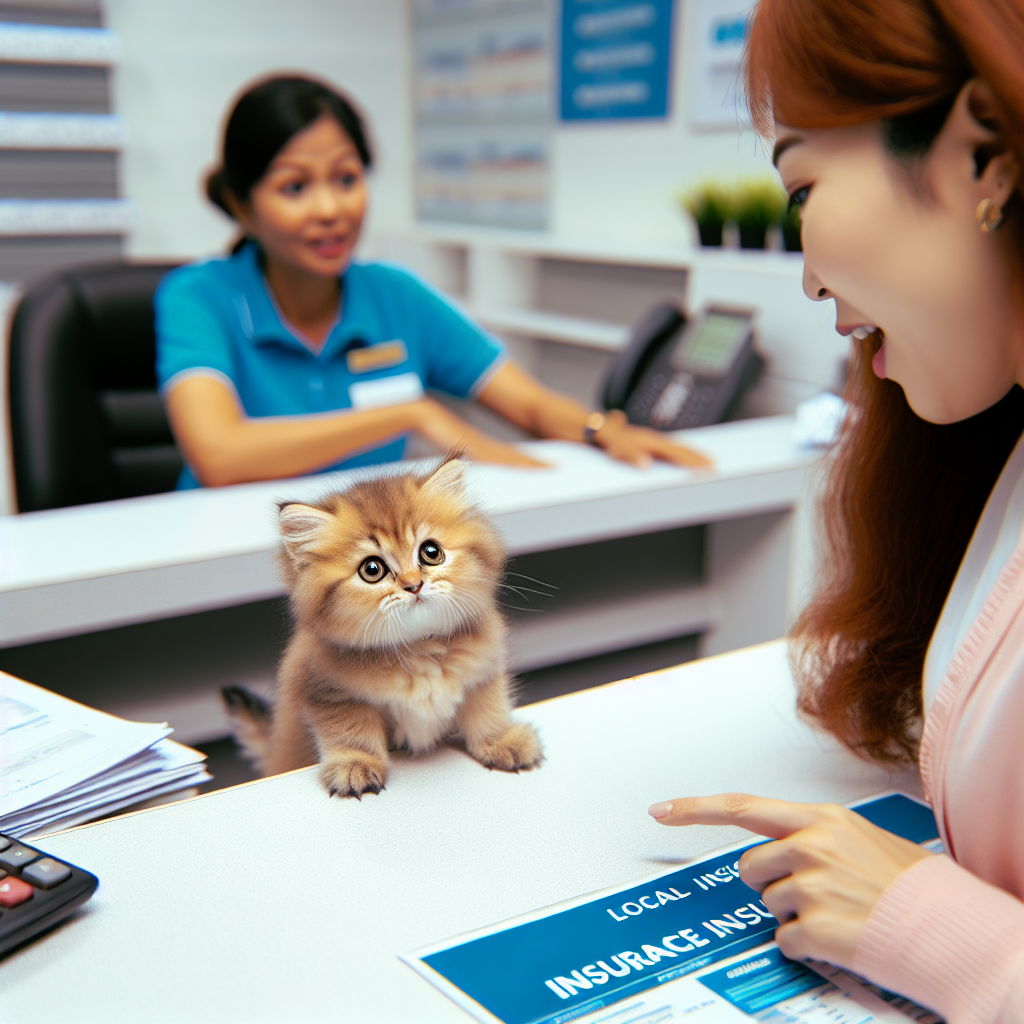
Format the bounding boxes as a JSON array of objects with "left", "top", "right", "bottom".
[{"left": 0, "top": 416, "right": 815, "bottom": 647}]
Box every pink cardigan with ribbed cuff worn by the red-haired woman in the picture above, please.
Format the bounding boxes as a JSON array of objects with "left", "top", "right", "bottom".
[{"left": 853, "top": 534, "right": 1024, "bottom": 1024}]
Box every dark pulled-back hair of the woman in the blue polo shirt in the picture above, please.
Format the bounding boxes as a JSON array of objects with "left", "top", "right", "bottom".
[{"left": 206, "top": 76, "right": 373, "bottom": 217}]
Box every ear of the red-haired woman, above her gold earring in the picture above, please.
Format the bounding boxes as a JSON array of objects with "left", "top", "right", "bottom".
[{"left": 935, "top": 78, "right": 1021, "bottom": 209}]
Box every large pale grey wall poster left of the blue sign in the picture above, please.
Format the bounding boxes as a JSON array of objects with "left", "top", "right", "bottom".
[{"left": 412, "top": 0, "right": 553, "bottom": 229}]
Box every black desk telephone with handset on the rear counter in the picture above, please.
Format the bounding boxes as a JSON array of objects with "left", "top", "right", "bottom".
[{"left": 604, "top": 304, "right": 764, "bottom": 430}]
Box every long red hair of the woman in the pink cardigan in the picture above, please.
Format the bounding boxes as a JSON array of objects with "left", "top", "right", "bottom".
[{"left": 745, "top": 0, "right": 1024, "bottom": 761}]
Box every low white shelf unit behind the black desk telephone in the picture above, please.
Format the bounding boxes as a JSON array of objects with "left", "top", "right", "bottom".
[{"left": 364, "top": 225, "right": 847, "bottom": 416}]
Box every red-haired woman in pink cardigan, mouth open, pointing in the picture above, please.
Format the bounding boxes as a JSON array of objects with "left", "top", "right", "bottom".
[{"left": 650, "top": 0, "right": 1024, "bottom": 1024}]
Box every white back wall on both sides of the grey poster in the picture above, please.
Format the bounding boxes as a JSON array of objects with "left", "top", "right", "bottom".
[{"left": 105, "top": 0, "right": 768, "bottom": 258}]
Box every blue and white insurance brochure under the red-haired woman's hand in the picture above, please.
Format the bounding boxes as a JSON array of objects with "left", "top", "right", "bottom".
[{"left": 401, "top": 793, "right": 942, "bottom": 1024}]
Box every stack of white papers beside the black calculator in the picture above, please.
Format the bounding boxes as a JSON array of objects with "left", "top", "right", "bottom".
[{"left": 0, "top": 673, "right": 211, "bottom": 838}]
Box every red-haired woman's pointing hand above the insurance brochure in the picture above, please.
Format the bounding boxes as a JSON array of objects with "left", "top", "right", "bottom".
[{"left": 649, "top": 793, "right": 932, "bottom": 968}]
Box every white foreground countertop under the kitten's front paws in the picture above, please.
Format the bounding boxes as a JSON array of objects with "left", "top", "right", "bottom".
[{"left": 0, "top": 642, "right": 920, "bottom": 1024}]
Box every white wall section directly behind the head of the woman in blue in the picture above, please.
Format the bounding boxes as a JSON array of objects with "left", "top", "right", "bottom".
[{"left": 104, "top": 0, "right": 411, "bottom": 258}]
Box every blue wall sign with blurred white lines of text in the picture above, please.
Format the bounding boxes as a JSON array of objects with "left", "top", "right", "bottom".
[{"left": 560, "top": 0, "right": 674, "bottom": 121}]
